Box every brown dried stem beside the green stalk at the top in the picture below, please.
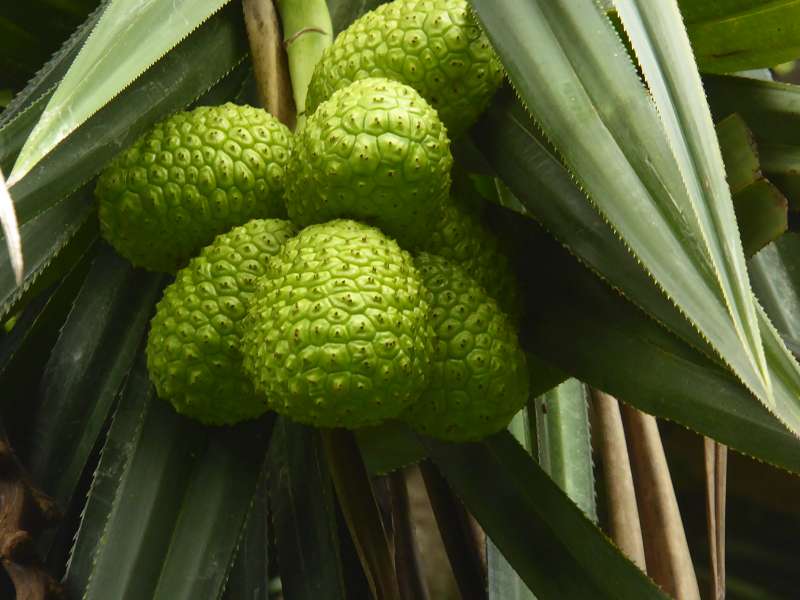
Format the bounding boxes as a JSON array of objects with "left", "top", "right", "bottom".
[{"left": 242, "top": 0, "right": 296, "bottom": 129}]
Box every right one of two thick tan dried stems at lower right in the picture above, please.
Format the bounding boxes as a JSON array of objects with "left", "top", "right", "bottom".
[{"left": 622, "top": 405, "right": 700, "bottom": 600}]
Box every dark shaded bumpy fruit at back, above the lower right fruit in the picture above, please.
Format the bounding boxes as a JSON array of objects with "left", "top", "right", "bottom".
[{"left": 422, "top": 197, "right": 519, "bottom": 314}]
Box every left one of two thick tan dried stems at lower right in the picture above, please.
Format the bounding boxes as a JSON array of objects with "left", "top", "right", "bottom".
[{"left": 592, "top": 390, "right": 647, "bottom": 572}]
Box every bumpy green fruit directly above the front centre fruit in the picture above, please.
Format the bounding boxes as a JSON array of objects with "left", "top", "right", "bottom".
[{"left": 286, "top": 79, "right": 453, "bottom": 243}]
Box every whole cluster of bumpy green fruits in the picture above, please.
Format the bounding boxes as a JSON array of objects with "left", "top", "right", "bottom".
[{"left": 103, "top": 0, "right": 528, "bottom": 441}]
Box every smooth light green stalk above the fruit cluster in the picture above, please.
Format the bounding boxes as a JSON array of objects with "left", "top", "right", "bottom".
[{"left": 277, "top": 0, "right": 333, "bottom": 126}]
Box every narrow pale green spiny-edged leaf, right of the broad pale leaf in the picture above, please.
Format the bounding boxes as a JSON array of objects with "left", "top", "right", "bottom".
[{"left": 616, "top": 0, "right": 771, "bottom": 401}]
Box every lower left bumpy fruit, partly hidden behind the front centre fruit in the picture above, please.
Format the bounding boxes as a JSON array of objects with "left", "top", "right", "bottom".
[{"left": 147, "top": 219, "right": 295, "bottom": 425}]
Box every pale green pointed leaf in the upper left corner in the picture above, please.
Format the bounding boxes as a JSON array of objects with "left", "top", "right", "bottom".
[{"left": 9, "top": 0, "right": 233, "bottom": 185}]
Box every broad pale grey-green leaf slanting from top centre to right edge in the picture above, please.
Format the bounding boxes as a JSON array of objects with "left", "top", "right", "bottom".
[{"left": 473, "top": 0, "right": 800, "bottom": 432}]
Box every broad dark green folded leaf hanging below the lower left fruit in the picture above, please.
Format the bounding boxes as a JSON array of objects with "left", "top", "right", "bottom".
[{"left": 68, "top": 356, "right": 269, "bottom": 600}]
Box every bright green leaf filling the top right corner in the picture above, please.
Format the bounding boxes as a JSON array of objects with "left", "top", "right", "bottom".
[{"left": 679, "top": 0, "right": 800, "bottom": 73}]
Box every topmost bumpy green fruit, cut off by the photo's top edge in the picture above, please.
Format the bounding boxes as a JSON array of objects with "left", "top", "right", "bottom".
[{"left": 307, "top": 0, "right": 503, "bottom": 137}]
